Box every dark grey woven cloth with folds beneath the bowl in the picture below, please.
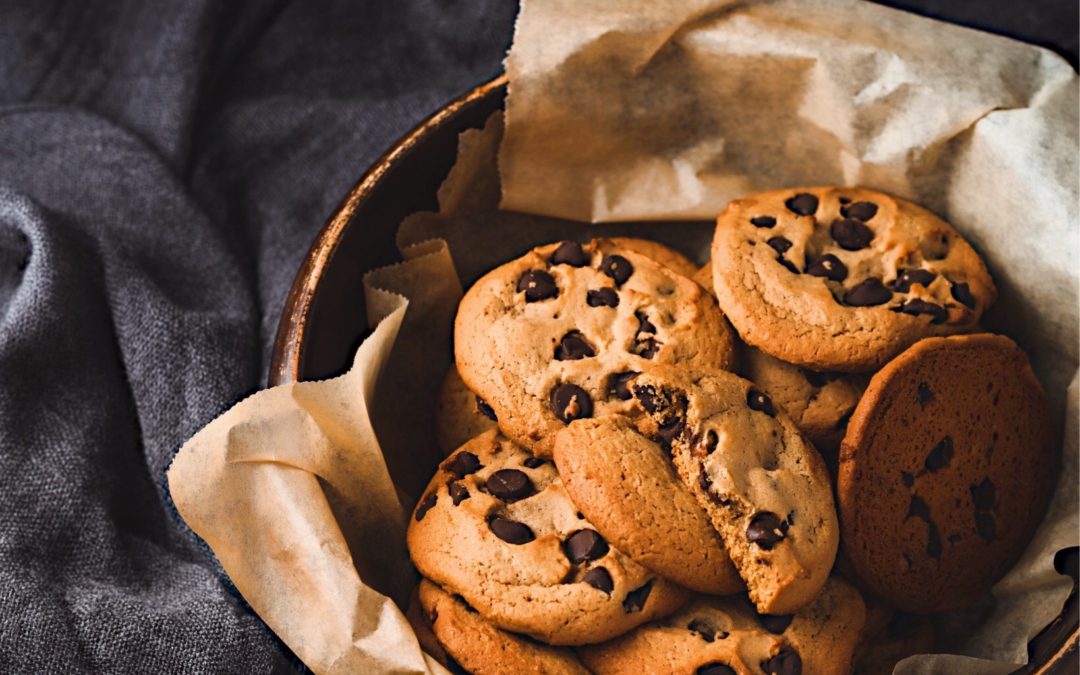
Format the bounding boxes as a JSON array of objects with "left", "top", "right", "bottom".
[{"left": 0, "top": 0, "right": 1078, "bottom": 672}]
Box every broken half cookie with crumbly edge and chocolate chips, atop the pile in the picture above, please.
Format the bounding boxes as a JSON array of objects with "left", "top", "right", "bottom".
[{"left": 630, "top": 366, "right": 839, "bottom": 613}]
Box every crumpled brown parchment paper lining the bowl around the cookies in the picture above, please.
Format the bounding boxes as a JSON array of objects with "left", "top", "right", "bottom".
[{"left": 168, "top": 0, "right": 1080, "bottom": 673}]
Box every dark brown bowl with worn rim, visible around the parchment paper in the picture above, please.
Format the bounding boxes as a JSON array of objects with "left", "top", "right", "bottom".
[{"left": 270, "top": 77, "right": 1080, "bottom": 674}]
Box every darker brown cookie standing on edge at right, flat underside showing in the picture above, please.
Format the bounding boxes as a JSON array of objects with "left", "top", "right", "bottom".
[{"left": 837, "top": 334, "right": 1057, "bottom": 612}]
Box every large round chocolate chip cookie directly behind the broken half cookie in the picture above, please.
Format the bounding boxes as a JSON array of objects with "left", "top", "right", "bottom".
[{"left": 454, "top": 240, "right": 734, "bottom": 457}]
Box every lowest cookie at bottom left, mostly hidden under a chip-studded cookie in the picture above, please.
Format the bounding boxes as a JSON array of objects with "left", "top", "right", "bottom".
[{"left": 417, "top": 579, "right": 589, "bottom": 675}]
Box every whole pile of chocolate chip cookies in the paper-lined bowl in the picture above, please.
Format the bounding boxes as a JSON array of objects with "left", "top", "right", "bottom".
[{"left": 408, "top": 188, "right": 1055, "bottom": 674}]
